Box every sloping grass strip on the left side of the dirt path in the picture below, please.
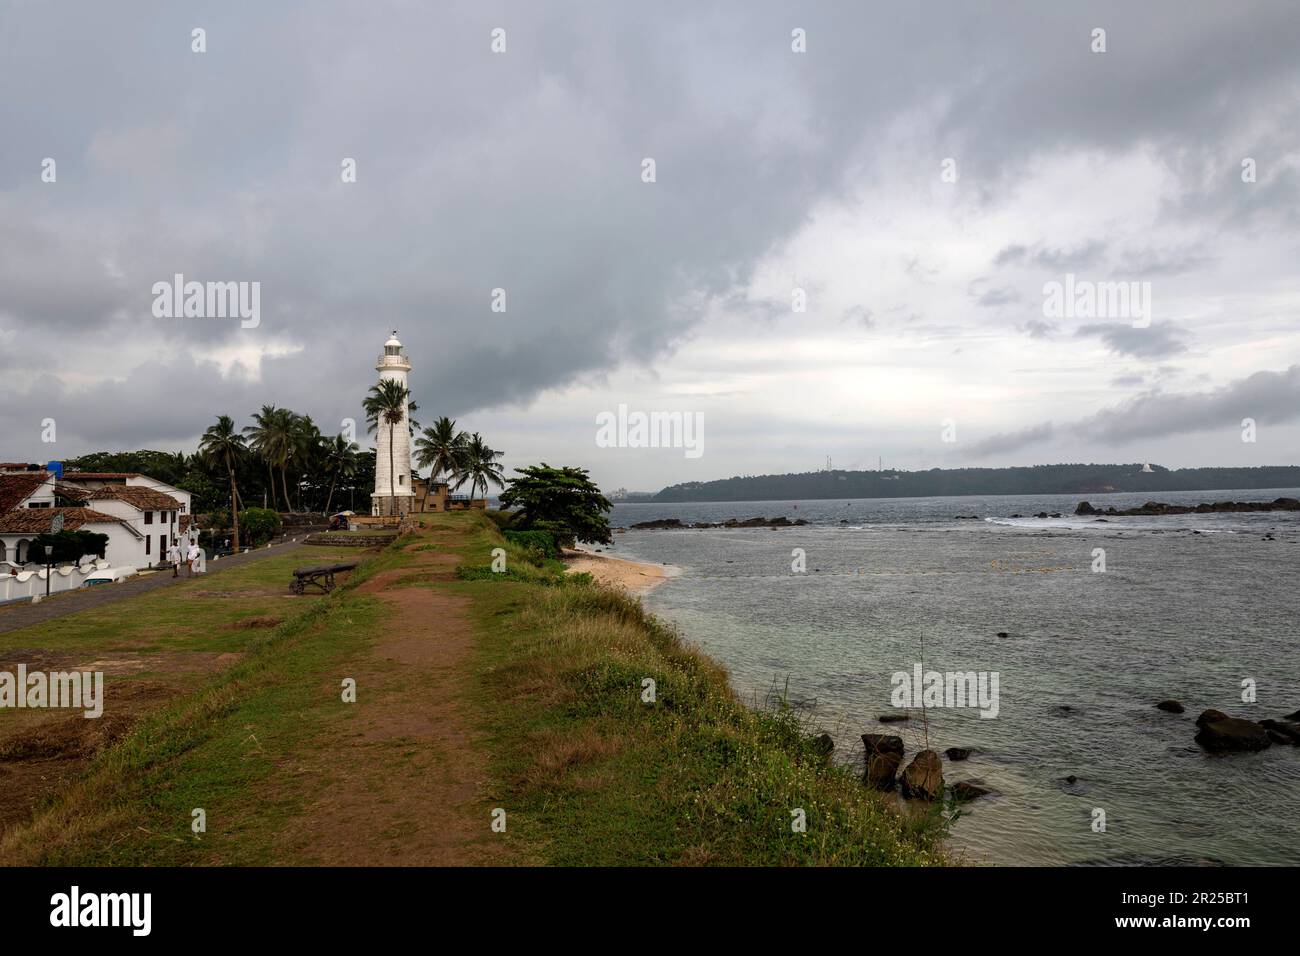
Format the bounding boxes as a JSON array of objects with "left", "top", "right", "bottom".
[{"left": 0, "top": 549, "right": 413, "bottom": 866}]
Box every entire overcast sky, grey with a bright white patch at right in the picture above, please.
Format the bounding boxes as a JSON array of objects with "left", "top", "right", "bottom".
[{"left": 0, "top": 0, "right": 1300, "bottom": 489}]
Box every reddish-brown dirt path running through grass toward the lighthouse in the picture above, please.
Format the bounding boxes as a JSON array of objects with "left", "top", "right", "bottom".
[{"left": 277, "top": 551, "right": 506, "bottom": 866}]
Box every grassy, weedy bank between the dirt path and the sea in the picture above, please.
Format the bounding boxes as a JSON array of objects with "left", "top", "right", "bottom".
[{"left": 452, "top": 522, "right": 944, "bottom": 865}]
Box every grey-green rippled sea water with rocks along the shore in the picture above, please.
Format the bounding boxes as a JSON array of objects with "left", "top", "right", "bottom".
[{"left": 610, "top": 489, "right": 1300, "bottom": 865}]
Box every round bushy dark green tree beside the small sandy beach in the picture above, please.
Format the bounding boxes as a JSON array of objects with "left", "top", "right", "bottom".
[{"left": 501, "top": 462, "right": 614, "bottom": 544}]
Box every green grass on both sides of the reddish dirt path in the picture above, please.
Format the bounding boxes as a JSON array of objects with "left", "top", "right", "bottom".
[{"left": 0, "top": 512, "right": 944, "bottom": 865}]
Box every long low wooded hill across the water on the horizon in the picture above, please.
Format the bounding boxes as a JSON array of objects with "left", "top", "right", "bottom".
[{"left": 653, "top": 462, "right": 1300, "bottom": 501}]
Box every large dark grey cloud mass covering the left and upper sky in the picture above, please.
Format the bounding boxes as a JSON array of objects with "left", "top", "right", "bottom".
[{"left": 0, "top": 0, "right": 1300, "bottom": 465}]
